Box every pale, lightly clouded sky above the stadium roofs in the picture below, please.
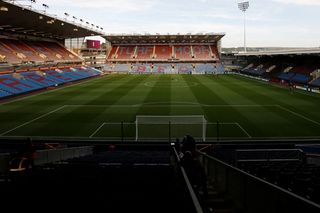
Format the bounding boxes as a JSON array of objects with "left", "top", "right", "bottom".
[{"left": 26, "top": 0, "right": 320, "bottom": 47}]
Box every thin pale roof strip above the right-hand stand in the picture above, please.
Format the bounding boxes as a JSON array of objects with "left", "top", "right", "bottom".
[{"left": 235, "top": 48, "right": 320, "bottom": 56}]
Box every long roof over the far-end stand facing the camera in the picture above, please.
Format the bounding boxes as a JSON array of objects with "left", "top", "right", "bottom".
[{"left": 104, "top": 33, "right": 225, "bottom": 44}]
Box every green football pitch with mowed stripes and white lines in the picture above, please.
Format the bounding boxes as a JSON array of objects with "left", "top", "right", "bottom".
[{"left": 0, "top": 75, "right": 320, "bottom": 140}]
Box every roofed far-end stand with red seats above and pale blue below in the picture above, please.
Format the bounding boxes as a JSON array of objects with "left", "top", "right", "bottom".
[{"left": 104, "top": 35, "right": 224, "bottom": 74}]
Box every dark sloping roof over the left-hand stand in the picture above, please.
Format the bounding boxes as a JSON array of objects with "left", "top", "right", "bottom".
[{"left": 0, "top": 1, "right": 101, "bottom": 39}]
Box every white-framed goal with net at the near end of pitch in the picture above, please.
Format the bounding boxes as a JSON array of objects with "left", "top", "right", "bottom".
[{"left": 135, "top": 115, "right": 207, "bottom": 141}]
